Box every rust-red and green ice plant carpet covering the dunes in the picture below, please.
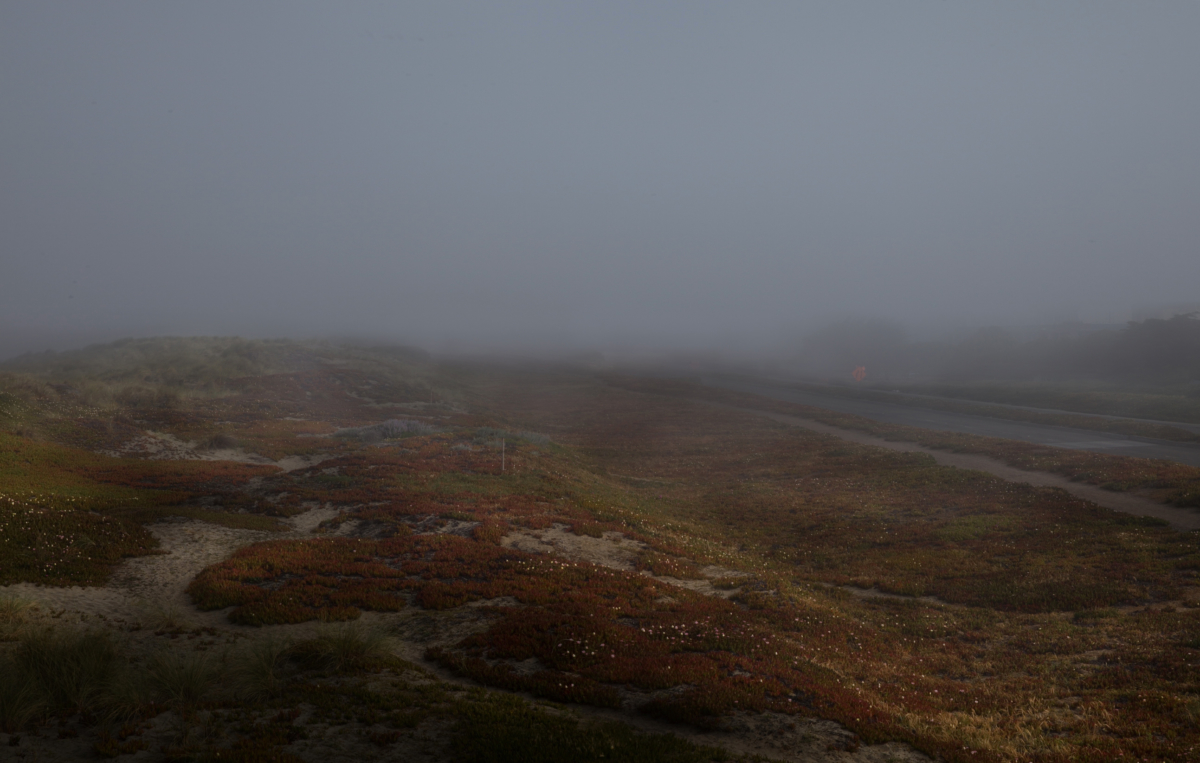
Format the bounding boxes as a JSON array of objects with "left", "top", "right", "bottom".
[{"left": 0, "top": 341, "right": 1200, "bottom": 762}]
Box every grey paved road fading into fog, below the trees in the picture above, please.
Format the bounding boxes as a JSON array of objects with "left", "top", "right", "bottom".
[{"left": 703, "top": 377, "right": 1200, "bottom": 467}]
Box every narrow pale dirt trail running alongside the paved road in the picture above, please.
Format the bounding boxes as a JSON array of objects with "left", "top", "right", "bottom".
[{"left": 724, "top": 403, "right": 1200, "bottom": 530}]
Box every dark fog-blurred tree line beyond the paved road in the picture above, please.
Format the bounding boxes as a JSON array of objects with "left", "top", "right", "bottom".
[{"left": 799, "top": 313, "right": 1200, "bottom": 384}]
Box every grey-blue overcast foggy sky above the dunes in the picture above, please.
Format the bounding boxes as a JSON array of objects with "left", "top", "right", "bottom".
[{"left": 0, "top": 0, "right": 1200, "bottom": 356}]
